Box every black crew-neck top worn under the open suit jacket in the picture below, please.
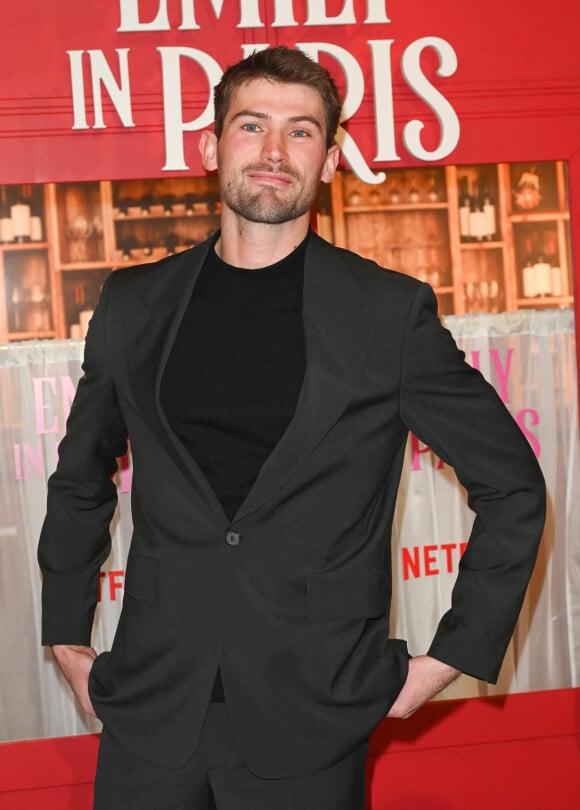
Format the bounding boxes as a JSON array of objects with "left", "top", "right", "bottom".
[{"left": 161, "top": 230, "right": 307, "bottom": 518}]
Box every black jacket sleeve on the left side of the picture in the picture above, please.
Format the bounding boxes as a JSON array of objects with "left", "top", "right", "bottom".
[{"left": 38, "top": 273, "right": 127, "bottom": 645}]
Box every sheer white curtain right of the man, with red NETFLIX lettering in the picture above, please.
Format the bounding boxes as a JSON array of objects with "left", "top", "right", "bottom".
[{"left": 394, "top": 310, "right": 580, "bottom": 698}]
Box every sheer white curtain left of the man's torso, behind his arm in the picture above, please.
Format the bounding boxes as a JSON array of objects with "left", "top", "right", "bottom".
[{"left": 0, "top": 340, "right": 131, "bottom": 741}]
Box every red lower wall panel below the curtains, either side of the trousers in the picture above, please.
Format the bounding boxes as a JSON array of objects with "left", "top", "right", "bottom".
[{"left": 0, "top": 689, "right": 580, "bottom": 810}]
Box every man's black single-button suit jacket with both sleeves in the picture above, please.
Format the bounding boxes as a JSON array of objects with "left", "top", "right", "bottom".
[{"left": 39, "top": 230, "right": 544, "bottom": 777}]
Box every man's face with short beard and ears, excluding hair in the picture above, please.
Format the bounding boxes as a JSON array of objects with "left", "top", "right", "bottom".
[{"left": 200, "top": 79, "right": 338, "bottom": 224}]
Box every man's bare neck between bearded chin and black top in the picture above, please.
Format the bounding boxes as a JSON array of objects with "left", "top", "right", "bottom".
[{"left": 215, "top": 207, "right": 310, "bottom": 270}]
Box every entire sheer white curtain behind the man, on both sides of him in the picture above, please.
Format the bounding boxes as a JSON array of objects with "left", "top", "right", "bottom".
[{"left": 0, "top": 310, "right": 580, "bottom": 740}]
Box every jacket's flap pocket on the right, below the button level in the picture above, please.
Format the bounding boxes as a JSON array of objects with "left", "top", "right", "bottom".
[{"left": 307, "top": 570, "right": 388, "bottom": 622}]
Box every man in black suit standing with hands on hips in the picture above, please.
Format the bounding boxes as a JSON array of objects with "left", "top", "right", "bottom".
[{"left": 39, "top": 47, "right": 545, "bottom": 810}]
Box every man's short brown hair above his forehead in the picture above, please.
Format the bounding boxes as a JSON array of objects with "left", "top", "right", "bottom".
[{"left": 214, "top": 45, "right": 342, "bottom": 149}]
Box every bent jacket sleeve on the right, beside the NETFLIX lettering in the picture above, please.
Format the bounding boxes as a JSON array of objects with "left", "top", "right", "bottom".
[{"left": 400, "top": 285, "right": 546, "bottom": 682}]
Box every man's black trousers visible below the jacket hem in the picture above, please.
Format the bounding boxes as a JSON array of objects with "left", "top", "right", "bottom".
[{"left": 94, "top": 703, "right": 368, "bottom": 810}]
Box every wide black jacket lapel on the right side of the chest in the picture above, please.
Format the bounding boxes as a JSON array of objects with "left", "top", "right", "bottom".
[{"left": 236, "top": 234, "right": 372, "bottom": 519}]
